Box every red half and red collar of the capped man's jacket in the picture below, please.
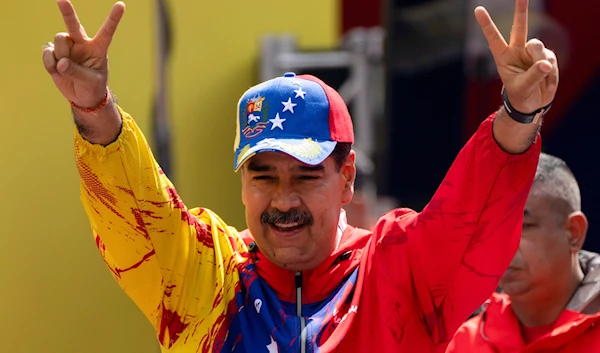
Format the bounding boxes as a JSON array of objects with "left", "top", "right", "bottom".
[{"left": 245, "top": 112, "right": 541, "bottom": 353}]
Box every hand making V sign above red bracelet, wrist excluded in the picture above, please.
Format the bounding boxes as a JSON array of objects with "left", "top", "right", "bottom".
[{"left": 42, "top": 0, "right": 125, "bottom": 108}]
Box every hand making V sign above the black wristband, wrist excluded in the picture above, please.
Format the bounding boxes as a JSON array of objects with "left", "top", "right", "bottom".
[{"left": 475, "top": 0, "right": 558, "bottom": 114}]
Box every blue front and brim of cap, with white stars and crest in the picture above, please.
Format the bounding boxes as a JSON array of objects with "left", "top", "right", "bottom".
[{"left": 234, "top": 73, "right": 335, "bottom": 170}]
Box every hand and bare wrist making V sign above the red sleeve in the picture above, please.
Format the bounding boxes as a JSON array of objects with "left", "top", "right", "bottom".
[{"left": 475, "top": 0, "right": 558, "bottom": 153}]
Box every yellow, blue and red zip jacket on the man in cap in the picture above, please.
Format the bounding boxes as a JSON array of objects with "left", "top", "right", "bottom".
[{"left": 75, "top": 111, "right": 540, "bottom": 353}]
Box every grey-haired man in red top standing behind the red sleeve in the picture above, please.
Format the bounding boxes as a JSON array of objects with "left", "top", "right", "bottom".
[{"left": 446, "top": 153, "right": 600, "bottom": 353}]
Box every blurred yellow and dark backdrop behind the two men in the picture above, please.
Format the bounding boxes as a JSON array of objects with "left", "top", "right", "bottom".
[{"left": 0, "top": 0, "right": 600, "bottom": 353}]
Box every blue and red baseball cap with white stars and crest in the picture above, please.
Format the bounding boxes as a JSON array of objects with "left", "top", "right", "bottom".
[{"left": 233, "top": 72, "right": 354, "bottom": 171}]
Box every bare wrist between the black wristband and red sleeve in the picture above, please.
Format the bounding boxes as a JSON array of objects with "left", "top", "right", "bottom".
[{"left": 492, "top": 107, "right": 543, "bottom": 154}]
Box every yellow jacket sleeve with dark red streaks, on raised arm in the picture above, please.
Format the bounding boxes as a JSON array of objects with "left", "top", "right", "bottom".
[{"left": 75, "top": 108, "right": 247, "bottom": 352}]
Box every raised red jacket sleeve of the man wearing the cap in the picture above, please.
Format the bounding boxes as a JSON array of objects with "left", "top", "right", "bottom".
[{"left": 376, "top": 114, "right": 541, "bottom": 343}]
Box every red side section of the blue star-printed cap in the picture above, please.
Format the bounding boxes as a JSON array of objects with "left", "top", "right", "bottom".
[{"left": 298, "top": 75, "right": 354, "bottom": 143}]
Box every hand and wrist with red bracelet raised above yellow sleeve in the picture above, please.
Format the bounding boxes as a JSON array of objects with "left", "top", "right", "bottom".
[{"left": 42, "top": 0, "right": 125, "bottom": 144}]
